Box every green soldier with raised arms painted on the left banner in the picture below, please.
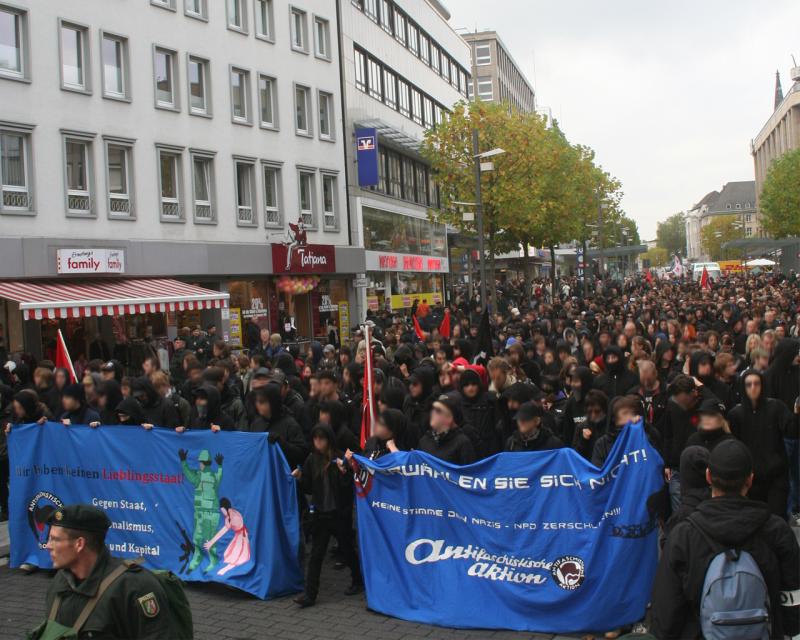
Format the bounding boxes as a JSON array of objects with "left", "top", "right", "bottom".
[{"left": 178, "top": 449, "right": 222, "bottom": 573}]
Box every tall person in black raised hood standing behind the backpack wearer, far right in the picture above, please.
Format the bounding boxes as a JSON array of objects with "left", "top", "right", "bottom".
[{"left": 728, "top": 369, "right": 794, "bottom": 517}]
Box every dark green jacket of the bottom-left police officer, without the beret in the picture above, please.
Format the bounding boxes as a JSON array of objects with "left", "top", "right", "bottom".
[{"left": 45, "top": 549, "right": 170, "bottom": 640}]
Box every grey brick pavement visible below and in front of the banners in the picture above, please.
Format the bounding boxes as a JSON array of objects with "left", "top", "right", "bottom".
[{"left": 0, "top": 560, "right": 564, "bottom": 640}]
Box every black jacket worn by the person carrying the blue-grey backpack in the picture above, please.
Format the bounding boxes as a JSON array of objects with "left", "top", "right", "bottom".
[{"left": 651, "top": 496, "right": 800, "bottom": 640}]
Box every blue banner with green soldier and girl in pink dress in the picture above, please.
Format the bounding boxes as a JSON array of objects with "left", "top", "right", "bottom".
[{"left": 8, "top": 422, "right": 303, "bottom": 598}]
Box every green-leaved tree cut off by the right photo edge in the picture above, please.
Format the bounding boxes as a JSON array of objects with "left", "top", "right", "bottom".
[{"left": 760, "top": 149, "right": 800, "bottom": 238}]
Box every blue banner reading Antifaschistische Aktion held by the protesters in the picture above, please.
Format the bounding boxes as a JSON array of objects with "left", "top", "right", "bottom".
[{"left": 357, "top": 424, "right": 663, "bottom": 633}]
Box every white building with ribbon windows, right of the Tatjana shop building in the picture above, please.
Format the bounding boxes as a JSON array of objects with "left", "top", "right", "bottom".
[{"left": 340, "top": 0, "right": 470, "bottom": 318}]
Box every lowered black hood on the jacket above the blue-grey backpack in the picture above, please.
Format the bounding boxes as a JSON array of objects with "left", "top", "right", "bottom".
[{"left": 695, "top": 496, "right": 771, "bottom": 546}]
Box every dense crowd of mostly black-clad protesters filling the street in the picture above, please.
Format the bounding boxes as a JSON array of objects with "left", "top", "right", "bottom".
[{"left": 0, "top": 273, "right": 800, "bottom": 638}]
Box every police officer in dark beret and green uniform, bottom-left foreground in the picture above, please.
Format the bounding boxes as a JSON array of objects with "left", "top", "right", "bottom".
[{"left": 32, "top": 504, "right": 170, "bottom": 640}]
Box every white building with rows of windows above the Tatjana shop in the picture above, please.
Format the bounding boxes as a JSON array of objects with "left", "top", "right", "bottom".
[{"left": 0, "top": 0, "right": 364, "bottom": 352}]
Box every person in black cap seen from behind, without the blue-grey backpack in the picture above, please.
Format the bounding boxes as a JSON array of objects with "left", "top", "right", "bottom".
[{"left": 650, "top": 440, "right": 800, "bottom": 640}]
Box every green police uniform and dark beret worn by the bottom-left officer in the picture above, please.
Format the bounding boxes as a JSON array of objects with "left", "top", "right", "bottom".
[{"left": 32, "top": 505, "right": 170, "bottom": 640}]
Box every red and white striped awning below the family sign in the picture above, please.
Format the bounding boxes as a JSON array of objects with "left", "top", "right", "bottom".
[{"left": 0, "top": 278, "right": 229, "bottom": 320}]
